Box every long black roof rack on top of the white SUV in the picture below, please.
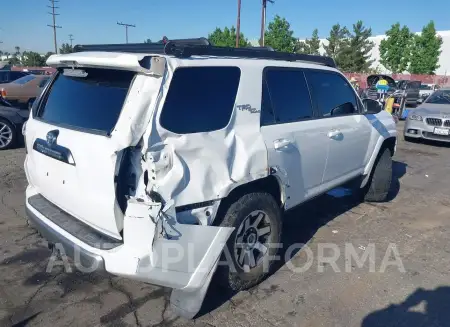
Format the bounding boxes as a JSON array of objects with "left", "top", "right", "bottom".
[{"left": 74, "top": 38, "right": 336, "bottom": 68}]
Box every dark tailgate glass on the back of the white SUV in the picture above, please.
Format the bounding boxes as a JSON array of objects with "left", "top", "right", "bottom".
[{"left": 37, "top": 68, "right": 134, "bottom": 134}]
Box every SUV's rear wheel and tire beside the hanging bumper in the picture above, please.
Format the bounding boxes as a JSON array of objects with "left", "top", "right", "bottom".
[{"left": 217, "top": 193, "right": 282, "bottom": 291}]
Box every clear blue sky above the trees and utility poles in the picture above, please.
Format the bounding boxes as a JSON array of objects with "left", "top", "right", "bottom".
[{"left": 0, "top": 0, "right": 450, "bottom": 53}]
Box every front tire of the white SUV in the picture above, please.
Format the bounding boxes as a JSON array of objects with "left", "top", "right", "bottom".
[{"left": 364, "top": 148, "right": 392, "bottom": 202}]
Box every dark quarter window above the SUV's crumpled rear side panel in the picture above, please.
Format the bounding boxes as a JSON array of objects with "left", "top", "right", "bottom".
[{"left": 160, "top": 67, "right": 241, "bottom": 134}]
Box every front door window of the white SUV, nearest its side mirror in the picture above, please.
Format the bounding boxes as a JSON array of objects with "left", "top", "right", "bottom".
[{"left": 306, "top": 71, "right": 358, "bottom": 117}]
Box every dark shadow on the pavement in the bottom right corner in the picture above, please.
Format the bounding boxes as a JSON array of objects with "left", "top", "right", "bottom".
[{"left": 361, "top": 286, "right": 450, "bottom": 327}]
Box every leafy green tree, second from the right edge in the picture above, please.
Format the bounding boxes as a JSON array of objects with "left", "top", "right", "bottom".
[{"left": 379, "top": 23, "right": 413, "bottom": 74}]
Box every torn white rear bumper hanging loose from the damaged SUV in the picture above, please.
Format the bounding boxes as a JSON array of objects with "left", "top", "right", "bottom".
[{"left": 26, "top": 186, "right": 233, "bottom": 291}]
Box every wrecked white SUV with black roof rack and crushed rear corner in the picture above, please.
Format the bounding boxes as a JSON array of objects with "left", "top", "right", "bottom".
[{"left": 24, "top": 39, "right": 396, "bottom": 317}]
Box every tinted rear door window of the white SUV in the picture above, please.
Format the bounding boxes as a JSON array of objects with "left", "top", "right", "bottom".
[{"left": 261, "top": 68, "right": 313, "bottom": 125}]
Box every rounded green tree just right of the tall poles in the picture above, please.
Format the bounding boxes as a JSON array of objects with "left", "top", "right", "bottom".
[{"left": 264, "top": 15, "right": 298, "bottom": 52}]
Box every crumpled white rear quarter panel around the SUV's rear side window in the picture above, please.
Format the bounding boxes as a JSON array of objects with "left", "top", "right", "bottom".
[{"left": 144, "top": 59, "right": 268, "bottom": 215}]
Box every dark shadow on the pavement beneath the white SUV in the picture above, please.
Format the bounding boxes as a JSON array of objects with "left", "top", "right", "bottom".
[{"left": 197, "top": 160, "right": 407, "bottom": 317}]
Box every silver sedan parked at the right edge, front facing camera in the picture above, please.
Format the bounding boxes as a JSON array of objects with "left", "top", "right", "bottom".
[{"left": 404, "top": 88, "right": 450, "bottom": 142}]
